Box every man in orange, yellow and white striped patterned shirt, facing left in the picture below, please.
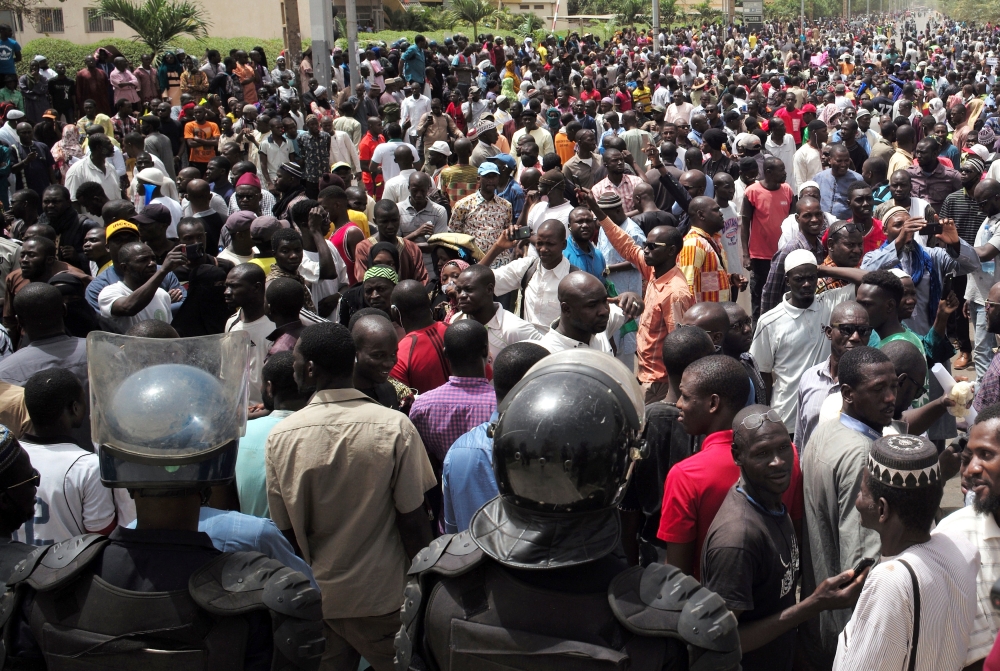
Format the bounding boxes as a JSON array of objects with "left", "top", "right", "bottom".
[{"left": 677, "top": 196, "right": 730, "bottom": 303}]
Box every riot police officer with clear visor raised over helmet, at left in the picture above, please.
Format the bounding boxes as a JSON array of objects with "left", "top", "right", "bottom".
[{"left": 0, "top": 332, "right": 324, "bottom": 671}]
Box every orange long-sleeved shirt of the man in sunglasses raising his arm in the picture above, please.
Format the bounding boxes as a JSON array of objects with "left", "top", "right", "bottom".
[{"left": 601, "top": 218, "right": 694, "bottom": 384}]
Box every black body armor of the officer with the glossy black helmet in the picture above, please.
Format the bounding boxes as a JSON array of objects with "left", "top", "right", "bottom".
[{"left": 395, "top": 532, "right": 740, "bottom": 671}]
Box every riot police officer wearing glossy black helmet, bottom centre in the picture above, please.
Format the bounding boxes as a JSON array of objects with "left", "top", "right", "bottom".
[{"left": 396, "top": 349, "right": 740, "bottom": 671}]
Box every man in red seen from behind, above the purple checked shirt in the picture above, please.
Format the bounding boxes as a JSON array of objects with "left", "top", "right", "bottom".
[{"left": 389, "top": 280, "right": 451, "bottom": 394}]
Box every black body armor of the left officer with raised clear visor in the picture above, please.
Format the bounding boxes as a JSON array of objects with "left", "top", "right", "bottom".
[{"left": 0, "top": 534, "right": 324, "bottom": 671}]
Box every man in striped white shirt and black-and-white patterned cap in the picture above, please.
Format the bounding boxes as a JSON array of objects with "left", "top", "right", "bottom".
[{"left": 833, "top": 435, "right": 980, "bottom": 671}]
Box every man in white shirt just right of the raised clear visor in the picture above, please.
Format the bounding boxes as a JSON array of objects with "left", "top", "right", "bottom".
[{"left": 224, "top": 264, "right": 276, "bottom": 404}]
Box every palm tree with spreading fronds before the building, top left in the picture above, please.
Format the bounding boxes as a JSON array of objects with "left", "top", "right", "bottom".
[{"left": 98, "top": 0, "right": 212, "bottom": 56}]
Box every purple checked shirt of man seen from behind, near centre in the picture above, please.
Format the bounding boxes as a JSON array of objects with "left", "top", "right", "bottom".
[{"left": 410, "top": 375, "right": 497, "bottom": 470}]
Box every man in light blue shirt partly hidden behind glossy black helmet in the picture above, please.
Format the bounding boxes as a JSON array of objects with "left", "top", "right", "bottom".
[{"left": 444, "top": 341, "right": 549, "bottom": 534}]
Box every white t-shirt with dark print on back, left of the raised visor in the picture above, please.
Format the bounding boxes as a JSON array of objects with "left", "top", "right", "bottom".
[{"left": 16, "top": 438, "right": 115, "bottom": 545}]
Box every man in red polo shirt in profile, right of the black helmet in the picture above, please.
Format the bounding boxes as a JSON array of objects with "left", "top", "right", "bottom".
[{"left": 656, "top": 354, "right": 803, "bottom": 580}]
